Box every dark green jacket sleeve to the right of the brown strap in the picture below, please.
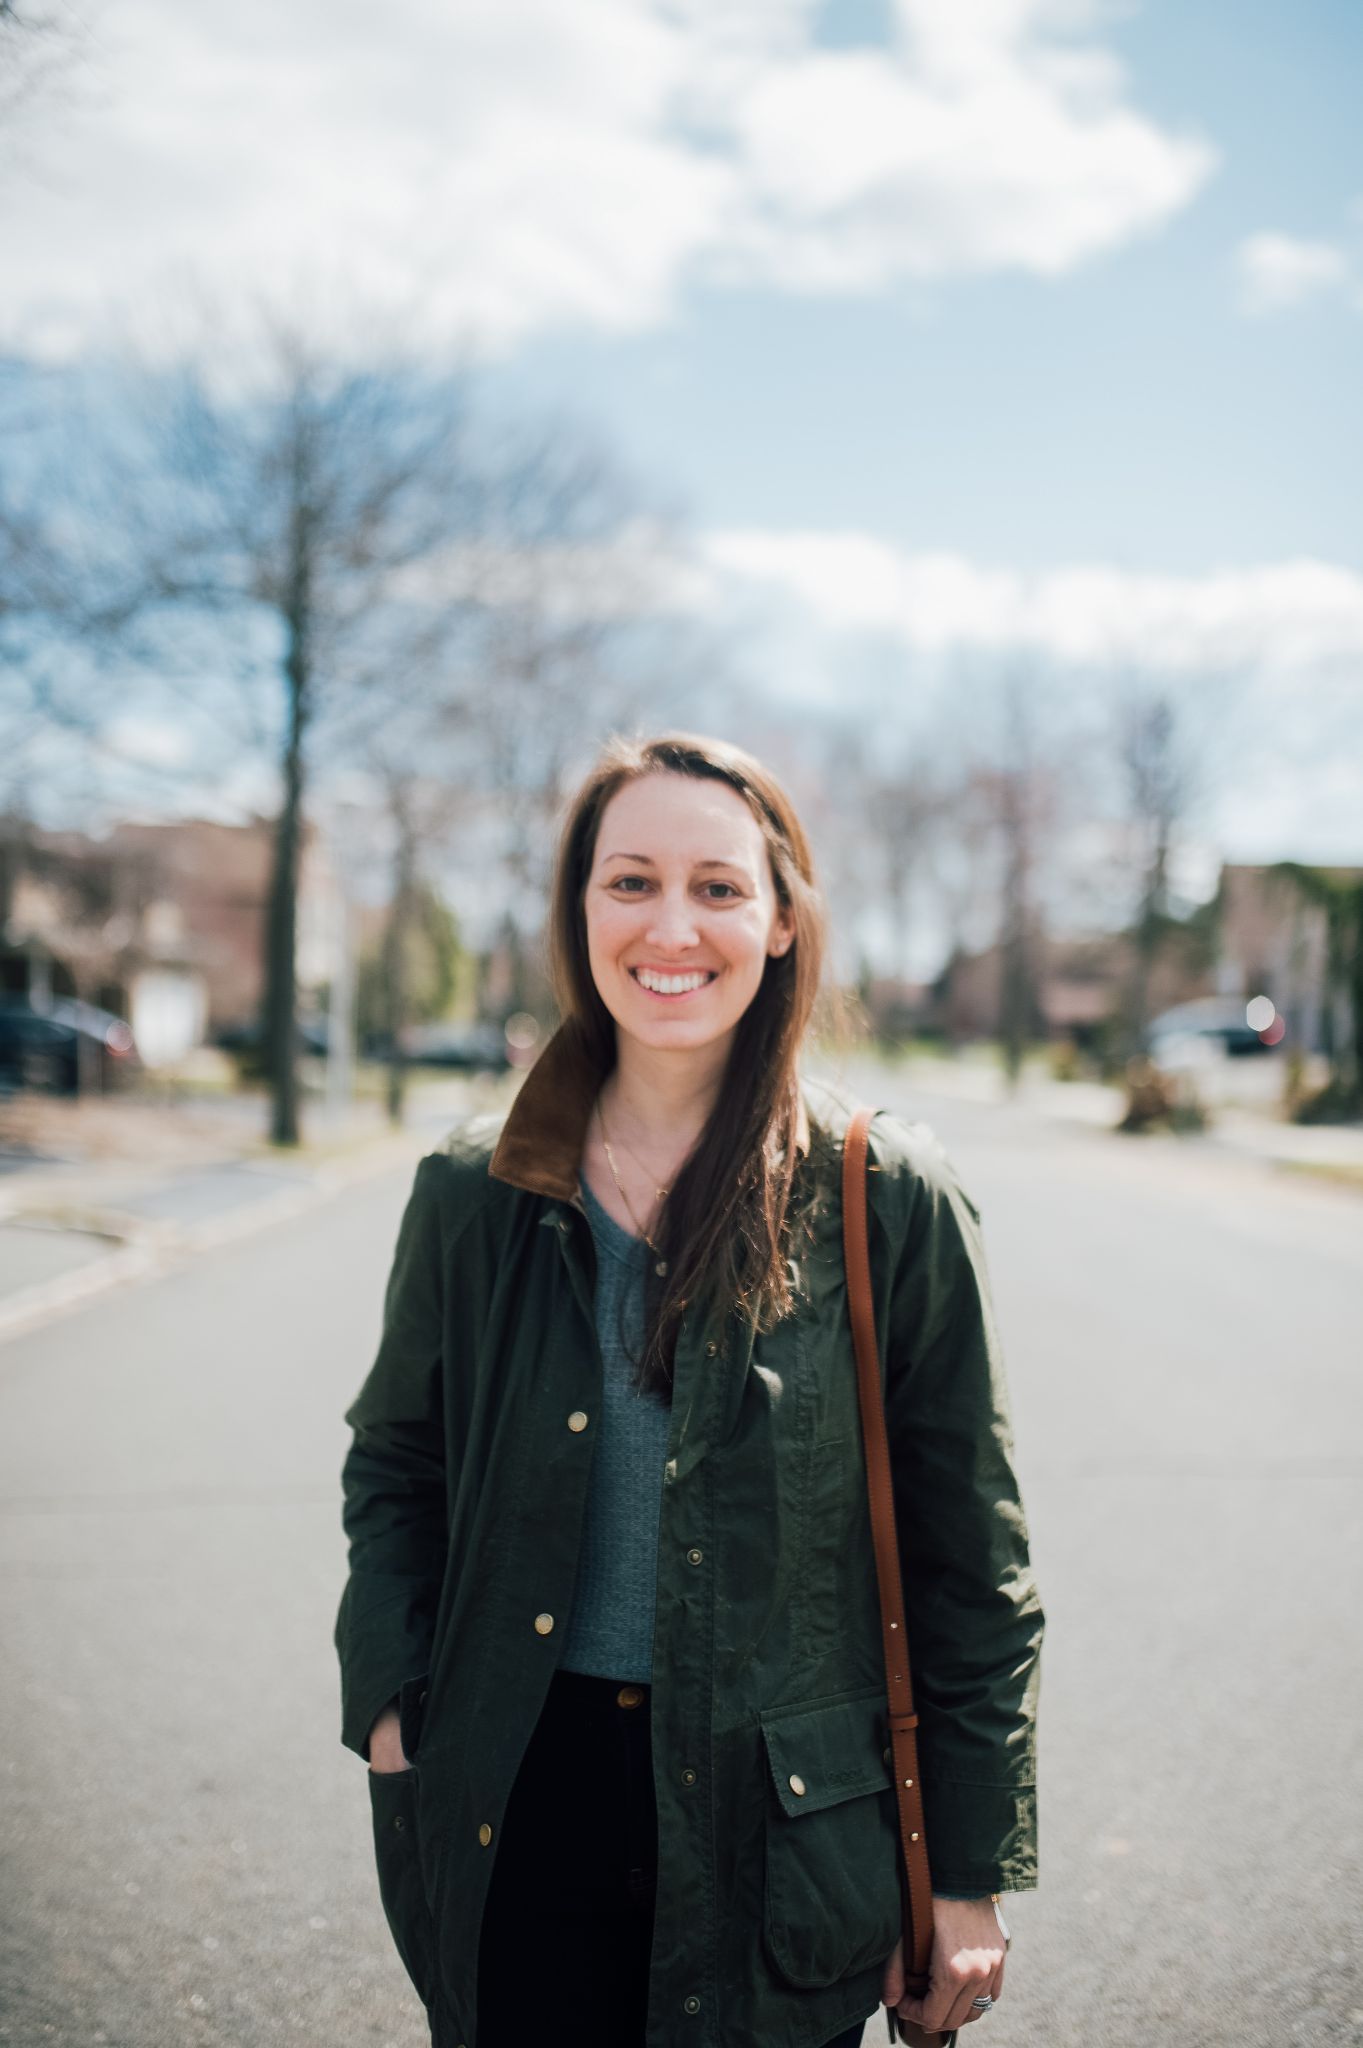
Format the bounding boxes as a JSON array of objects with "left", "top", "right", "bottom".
[{"left": 870, "top": 1122, "right": 1046, "bottom": 1896}]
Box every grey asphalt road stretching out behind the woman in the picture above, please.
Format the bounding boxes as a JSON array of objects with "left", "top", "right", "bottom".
[{"left": 0, "top": 1081, "right": 1363, "bottom": 2048}]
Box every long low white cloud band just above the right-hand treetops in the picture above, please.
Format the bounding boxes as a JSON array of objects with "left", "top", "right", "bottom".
[{"left": 706, "top": 530, "right": 1363, "bottom": 675}]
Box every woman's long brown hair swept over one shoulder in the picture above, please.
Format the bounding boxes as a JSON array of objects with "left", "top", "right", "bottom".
[{"left": 548, "top": 733, "right": 827, "bottom": 1395}]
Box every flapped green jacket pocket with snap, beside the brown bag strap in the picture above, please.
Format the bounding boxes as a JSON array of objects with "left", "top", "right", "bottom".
[{"left": 761, "top": 1690, "right": 903, "bottom": 1989}]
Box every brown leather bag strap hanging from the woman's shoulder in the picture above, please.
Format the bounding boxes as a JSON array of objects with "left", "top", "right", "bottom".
[{"left": 843, "top": 1108, "right": 939, "bottom": 1998}]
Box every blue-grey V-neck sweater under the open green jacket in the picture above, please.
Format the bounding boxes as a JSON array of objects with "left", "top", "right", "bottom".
[{"left": 559, "top": 1180, "right": 671, "bottom": 1686}]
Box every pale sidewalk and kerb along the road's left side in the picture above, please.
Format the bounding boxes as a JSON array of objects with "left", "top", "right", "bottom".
[{"left": 0, "top": 1075, "right": 503, "bottom": 1341}]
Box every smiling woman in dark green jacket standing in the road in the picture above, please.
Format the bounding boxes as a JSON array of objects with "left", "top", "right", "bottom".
[{"left": 336, "top": 735, "right": 1044, "bottom": 2048}]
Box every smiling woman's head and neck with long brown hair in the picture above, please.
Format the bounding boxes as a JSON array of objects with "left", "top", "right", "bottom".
[{"left": 553, "top": 735, "right": 823, "bottom": 1393}]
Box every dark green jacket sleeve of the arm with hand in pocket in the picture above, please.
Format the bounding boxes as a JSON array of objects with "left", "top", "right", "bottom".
[{"left": 334, "top": 1153, "right": 448, "bottom": 1757}]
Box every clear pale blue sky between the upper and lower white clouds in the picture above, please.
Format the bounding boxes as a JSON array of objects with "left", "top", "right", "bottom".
[{"left": 497, "top": 0, "right": 1363, "bottom": 571}]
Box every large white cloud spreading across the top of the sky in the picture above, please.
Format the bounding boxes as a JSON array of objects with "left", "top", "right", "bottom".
[{"left": 0, "top": 0, "right": 1216, "bottom": 350}]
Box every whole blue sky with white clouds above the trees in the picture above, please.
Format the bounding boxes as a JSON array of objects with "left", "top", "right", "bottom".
[{"left": 0, "top": 0, "right": 1363, "bottom": 888}]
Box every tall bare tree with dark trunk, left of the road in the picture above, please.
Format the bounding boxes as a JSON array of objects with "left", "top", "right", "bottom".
[{"left": 63, "top": 315, "right": 485, "bottom": 1145}]
